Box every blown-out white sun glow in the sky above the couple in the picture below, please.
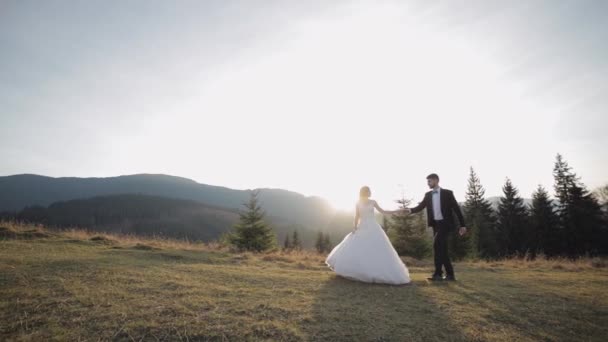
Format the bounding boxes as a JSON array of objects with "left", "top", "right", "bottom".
[{"left": 110, "top": 2, "right": 554, "bottom": 210}]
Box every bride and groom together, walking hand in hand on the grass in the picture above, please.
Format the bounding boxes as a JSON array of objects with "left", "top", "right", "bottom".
[{"left": 325, "top": 173, "right": 467, "bottom": 285}]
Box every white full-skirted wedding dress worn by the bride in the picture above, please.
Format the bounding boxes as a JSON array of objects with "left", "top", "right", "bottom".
[{"left": 325, "top": 200, "right": 410, "bottom": 285}]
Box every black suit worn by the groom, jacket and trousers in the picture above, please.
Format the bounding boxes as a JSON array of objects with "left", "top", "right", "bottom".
[{"left": 411, "top": 189, "right": 465, "bottom": 276}]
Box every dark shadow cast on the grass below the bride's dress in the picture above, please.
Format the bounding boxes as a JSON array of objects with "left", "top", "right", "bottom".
[{"left": 303, "top": 276, "right": 465, "bottom": 341}]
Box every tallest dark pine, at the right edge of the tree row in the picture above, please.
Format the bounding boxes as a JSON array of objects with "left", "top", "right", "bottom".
[{"left": 553, "top": 154, "right": 607, "bottom": 257}]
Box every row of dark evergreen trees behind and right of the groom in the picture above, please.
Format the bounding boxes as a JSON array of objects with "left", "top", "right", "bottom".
[{"left": 386, "top": 154, "right": 608, "bottom": 259}]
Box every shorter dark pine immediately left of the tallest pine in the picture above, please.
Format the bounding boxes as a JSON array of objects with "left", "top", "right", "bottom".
[{"left": 529, "top": 185, "right": 562, "bottom": 257}]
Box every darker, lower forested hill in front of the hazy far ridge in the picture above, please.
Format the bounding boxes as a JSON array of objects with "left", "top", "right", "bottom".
[{"left": 0, "top": 194, "right": 350, "bottom": 248}]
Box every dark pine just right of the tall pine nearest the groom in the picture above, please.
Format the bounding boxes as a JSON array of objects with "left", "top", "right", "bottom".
[{"left": 497, "top": 178, "right": 529, "bottom": 256}]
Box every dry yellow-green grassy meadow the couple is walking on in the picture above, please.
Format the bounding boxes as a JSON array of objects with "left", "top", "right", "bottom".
[{"left": 0, "top": 223, "right": 608, "bottom": 341}]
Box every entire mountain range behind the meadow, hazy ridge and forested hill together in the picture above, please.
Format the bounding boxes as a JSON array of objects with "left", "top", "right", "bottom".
[{"left": 0, "top": 174, "right": 352, "bottom": 246}]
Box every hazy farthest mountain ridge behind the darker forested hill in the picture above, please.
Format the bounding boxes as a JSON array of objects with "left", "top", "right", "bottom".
[{"left": 0, "top": 174, "right": 336, "bottom": 229}]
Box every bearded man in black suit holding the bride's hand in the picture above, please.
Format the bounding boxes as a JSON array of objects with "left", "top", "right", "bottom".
[{"left": 406, "top": 173, "right": 467, "bottom": 281}]
